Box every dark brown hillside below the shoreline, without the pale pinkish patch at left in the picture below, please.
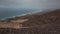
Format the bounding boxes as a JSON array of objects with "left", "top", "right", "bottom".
[{"left": 0, "top": 9, "right": 60, "bottom": 34}]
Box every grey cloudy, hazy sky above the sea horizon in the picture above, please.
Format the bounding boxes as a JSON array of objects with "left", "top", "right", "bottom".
[{"left": 0, "top": 0, "right": 60, "bottom": 9}]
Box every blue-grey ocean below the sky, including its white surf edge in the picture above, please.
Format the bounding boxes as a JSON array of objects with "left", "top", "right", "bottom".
[{"left": 0, "top": 9, "right": 36, "bottom": 20}]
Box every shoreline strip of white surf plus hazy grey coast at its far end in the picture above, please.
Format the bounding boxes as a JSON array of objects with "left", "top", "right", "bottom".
[{"left": 0, "top": 9, "right": 57, "bottom": 20}]
